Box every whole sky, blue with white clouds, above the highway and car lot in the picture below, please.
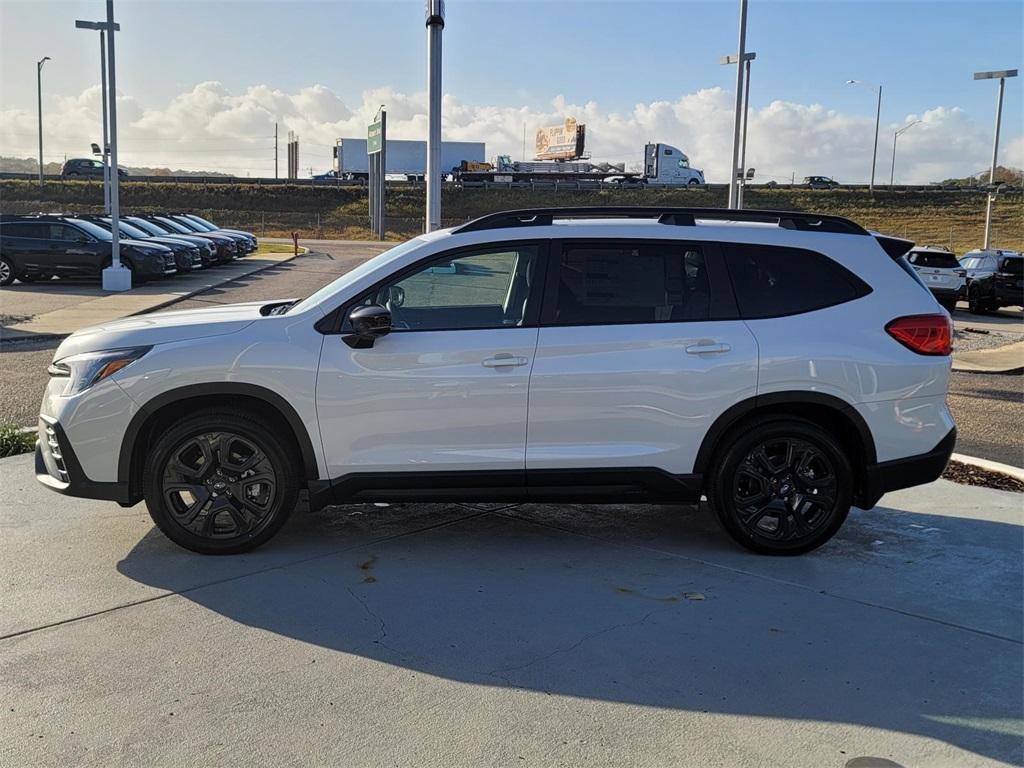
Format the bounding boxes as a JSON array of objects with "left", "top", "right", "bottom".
[{"left": 0, "top": 0, "right": 1024, "bottom": 183}]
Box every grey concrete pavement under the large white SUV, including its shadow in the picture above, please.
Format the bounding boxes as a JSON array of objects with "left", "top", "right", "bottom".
[{"left": 0, "top": 457, "right": 1024, "bottom": 768}]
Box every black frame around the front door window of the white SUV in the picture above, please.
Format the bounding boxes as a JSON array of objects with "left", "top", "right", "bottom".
[{"left": 313, "top": 238, "right": 551, "bottom": 336}]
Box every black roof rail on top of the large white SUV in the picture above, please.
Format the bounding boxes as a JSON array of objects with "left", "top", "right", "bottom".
[{"left": 453, "top": 206, "right": 868, "bottom": 234}]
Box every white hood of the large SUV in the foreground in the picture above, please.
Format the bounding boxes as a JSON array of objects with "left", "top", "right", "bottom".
[{"left": 53, "top": 301, "right": 270, "bottom": 360}]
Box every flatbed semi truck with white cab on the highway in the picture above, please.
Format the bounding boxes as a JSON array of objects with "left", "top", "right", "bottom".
[{"left": 455, "top": 143, "right": 706, "bottom": 186}]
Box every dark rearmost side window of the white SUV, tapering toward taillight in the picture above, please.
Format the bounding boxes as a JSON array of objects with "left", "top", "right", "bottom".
[{"left": 722, "top": 244, "right": 871, "bottom": 319}]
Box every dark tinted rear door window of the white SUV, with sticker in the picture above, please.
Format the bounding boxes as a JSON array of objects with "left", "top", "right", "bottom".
[{"left": 545, "top": 241, "right": 711, "bottom": 326}]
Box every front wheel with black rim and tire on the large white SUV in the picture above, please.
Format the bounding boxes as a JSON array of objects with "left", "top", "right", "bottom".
[{"left": 142, "top": 409, "right": 300, "bottom": 555}]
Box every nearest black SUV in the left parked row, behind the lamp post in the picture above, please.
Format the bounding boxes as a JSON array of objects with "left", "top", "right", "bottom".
[{"left": 0, "top": 215, "right": 177, "bottom": 286}]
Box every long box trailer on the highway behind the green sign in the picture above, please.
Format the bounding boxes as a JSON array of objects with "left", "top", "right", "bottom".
[{"left": 327, "top": 138, "right": 484, "bottom": 181}]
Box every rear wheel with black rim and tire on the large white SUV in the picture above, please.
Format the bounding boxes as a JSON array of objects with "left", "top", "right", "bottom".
[{"left": 708, "top": 416, "right": 853, "bottom": 555}]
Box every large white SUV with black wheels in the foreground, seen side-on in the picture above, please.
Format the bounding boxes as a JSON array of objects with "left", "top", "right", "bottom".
[{"left": 36, "top": 208, "right": 955, "bottom": 554}]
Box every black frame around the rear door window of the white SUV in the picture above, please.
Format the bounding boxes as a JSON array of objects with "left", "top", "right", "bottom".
[{"left": 540, "top": 237, "right": 739, "bottom": 328}]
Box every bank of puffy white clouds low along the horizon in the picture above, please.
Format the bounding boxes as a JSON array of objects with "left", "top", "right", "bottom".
[{"left": 0, "top": 82, "right": 1024, "bottom": 182}]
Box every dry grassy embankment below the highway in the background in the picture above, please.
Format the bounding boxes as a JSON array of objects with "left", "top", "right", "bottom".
[{"left": 0, "top": 180, "right": 1024, "bottom": 254}]
